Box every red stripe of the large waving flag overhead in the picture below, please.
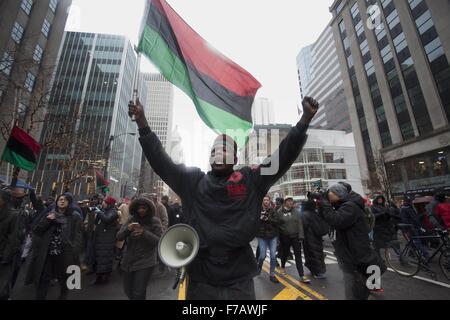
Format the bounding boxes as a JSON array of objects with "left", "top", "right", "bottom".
[{"left": 152, "top": 0, "right": 261, "bottom": 97}]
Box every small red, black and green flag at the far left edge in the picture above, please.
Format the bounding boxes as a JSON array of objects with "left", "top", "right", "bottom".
[{"left": 2, "top": 127, "right": 42, "bottom": 171}]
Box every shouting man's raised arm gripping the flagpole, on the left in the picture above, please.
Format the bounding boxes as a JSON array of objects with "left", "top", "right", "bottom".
[{"left": 129, "top": 99, "right": 203, "bottom": 197}]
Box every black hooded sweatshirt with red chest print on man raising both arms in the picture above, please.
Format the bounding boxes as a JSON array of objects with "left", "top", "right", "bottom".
[{"left": 139, "top": 123, "right": 307, "bottom": 286}]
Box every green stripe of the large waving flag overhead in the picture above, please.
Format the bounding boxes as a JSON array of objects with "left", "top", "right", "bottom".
[{"left": 139, "top": 26, "right": 253, "bottom": 147}]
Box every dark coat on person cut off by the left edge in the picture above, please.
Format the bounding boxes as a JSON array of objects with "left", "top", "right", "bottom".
[{"left": 0, "top": 207, "right": 20, "bottom": 264}]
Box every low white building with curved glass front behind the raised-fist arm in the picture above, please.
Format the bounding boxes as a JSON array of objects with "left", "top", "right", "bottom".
[{"left": 240, "top": 124, "right": 364, "bottom": 201}]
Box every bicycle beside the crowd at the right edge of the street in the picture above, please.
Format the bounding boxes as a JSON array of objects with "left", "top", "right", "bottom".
[{"left": 385, "top": 224, "right": 450, "bottom": 281}]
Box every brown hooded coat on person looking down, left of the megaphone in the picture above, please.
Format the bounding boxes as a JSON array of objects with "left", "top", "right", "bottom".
[{"left": 117, "top": 198, "right": 162, "bottom": 272}]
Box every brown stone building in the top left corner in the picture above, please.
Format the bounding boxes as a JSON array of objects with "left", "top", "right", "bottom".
[{"left": 0, "top": 0, "right": 72, "bottom": 180}]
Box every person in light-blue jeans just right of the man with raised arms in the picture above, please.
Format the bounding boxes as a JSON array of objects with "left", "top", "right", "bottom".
[{"left": 257, "top": 196, "right": 279, "bottom": 283}]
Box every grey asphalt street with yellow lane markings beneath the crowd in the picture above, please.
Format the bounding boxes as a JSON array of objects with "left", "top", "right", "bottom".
[{"left": 13, "top": 241, "right": 450, "bottom": 300}]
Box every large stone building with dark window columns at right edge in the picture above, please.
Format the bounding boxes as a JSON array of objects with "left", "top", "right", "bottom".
[{"left": 330, "top": 0, "right": 450, "bottom": 196}]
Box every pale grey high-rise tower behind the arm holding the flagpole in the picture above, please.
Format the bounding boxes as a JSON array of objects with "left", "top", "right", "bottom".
[{"left": 139, "top": 73, "right": 174, "bottom": 196}]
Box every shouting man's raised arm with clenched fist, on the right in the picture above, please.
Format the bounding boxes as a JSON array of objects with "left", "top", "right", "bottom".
[{"left": 255, "top": 97, "right": 319, "bottom": 193}]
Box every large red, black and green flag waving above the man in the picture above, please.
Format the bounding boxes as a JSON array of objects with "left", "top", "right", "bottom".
[{"left": 138, "top": 0, "right": 261, "bottom": 144}]
